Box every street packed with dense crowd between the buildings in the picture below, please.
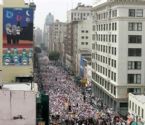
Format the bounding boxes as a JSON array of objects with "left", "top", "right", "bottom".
[{"left": 37, "top": 57, "right": 96, "bottom": 124}]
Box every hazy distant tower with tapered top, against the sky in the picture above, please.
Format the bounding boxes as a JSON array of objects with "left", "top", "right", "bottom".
[{"left": 43, "top": 13, "right": 54, "bottom": 48}]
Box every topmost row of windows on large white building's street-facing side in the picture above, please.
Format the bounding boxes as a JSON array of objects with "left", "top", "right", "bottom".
[{"left": 96, "top": 10, "right": 117, "bottom": 20}]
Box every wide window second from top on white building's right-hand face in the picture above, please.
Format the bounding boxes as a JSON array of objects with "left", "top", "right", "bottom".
[{"left": 128, "top": 22, "right": 142, "bottom": 31}]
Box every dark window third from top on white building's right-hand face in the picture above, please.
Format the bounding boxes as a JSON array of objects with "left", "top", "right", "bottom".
[{"left": 128, "top": 35, "right": 142, "bottom": 43}]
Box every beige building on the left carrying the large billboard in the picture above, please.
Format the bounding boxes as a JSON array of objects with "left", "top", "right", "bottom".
[{"left": 0, "top": 0, "right": 34, "bottom": 83}]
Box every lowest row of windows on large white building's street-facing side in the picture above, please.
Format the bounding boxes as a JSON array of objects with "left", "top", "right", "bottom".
[{"left": 92, "top": 72, "right": 116, "bottom": 96}]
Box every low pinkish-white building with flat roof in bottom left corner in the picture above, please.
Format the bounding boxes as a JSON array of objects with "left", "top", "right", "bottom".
[{"left": 0, "top": 83, "right": 37, "bottom": 125}]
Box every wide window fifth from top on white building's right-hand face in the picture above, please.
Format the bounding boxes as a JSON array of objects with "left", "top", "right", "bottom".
[{"left": 128, "top": 61, "right": 141, "bottom": 69}]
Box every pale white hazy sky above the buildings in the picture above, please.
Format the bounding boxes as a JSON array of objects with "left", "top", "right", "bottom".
[{"left": 32, "top": 0, "right": 93, "bottom": 28}]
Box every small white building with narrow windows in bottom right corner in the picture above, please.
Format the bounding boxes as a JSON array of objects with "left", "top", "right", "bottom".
[{"left": 128, "top": 93, "right": 145, "bottom": 123}]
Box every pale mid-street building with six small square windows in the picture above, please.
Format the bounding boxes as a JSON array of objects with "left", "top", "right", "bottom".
[{"left": 73, "top": 19, "right": 92, "bottom": 73}]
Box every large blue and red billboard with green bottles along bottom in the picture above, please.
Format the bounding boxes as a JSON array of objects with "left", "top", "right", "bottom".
[{"left": 3, "top": 8, "right": 33, "bottom": 66}]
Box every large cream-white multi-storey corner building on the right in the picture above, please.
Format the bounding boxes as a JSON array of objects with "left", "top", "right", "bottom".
[{"left": 92, "top": 0, "right": 145, "bottom": 114}]
